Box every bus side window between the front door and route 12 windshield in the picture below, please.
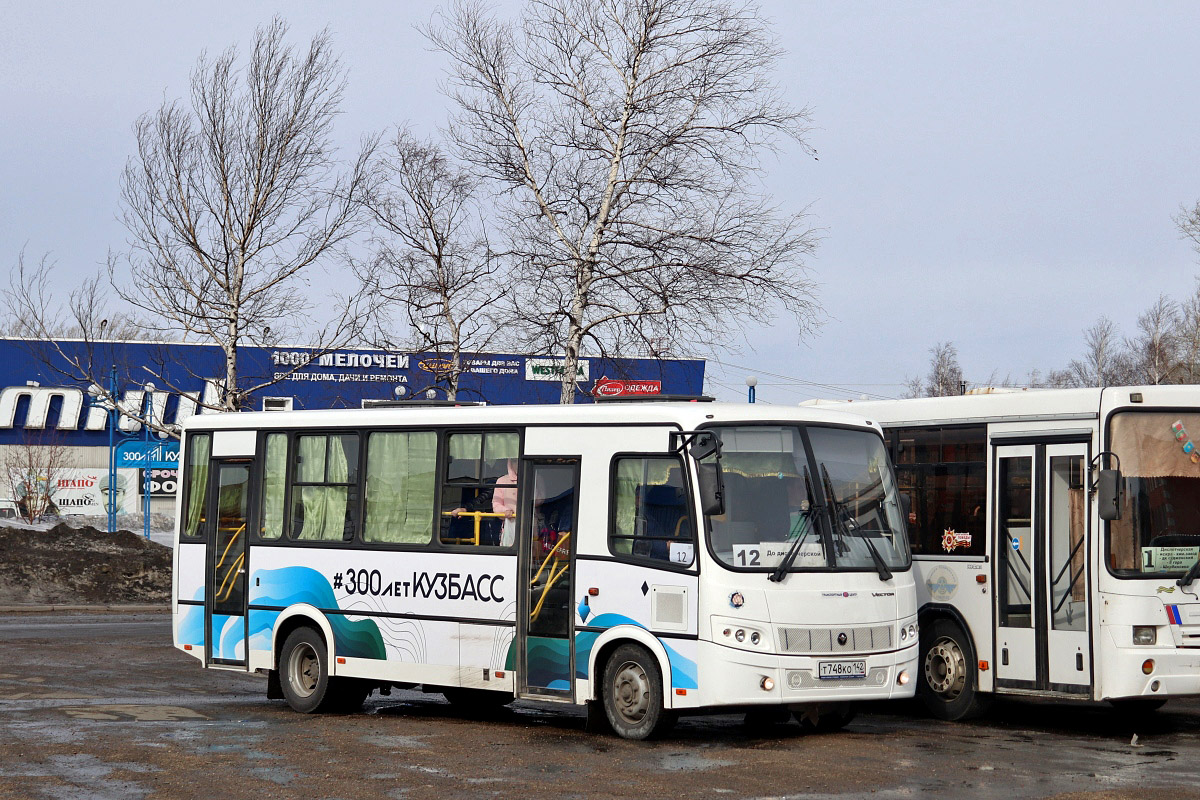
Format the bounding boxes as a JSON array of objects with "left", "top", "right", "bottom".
[{"left": 608, "top": 456, "right": 695, "bottom": 566}]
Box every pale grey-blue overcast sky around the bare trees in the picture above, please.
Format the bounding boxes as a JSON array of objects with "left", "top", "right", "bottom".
[{"left": 0, "top": 0, "right": 1200, "bottom": 403}]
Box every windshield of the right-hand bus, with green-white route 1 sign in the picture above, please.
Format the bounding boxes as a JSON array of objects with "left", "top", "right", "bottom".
[{"left": 1109, "top": 411, "right": 1200, "bottom": 577}]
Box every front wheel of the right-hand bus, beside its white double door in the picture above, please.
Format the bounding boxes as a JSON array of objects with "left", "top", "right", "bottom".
[{"left": 917, "top": 619, "right": 985, "bottom": 721}]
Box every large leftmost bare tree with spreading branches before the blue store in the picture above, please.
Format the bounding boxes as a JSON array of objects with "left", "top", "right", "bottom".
[{"left": 7, "top": 19, "right": 373, "bottom": 422}]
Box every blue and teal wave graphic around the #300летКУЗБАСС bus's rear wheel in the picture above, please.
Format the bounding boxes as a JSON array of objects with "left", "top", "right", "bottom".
[{"left": 250, "top": 566, "right": 388, "bottom": 658}]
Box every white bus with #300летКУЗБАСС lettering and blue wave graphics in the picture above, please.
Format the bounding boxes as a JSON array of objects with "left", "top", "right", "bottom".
[{"left": 173, "top": 402, "right": 917, "bottom": 739}]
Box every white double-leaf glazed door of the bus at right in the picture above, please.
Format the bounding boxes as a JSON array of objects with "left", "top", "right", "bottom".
[{"left": 992, "top": 444, "right": 1092, "bottom": 694}]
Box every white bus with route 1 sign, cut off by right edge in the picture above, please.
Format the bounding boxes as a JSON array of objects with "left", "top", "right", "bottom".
[{"left": 845, "top": 386, "right": 1200, "bottom": 720}]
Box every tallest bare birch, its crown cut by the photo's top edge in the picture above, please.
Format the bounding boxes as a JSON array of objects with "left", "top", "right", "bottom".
[{"left": 427, "top": 0, "right": 817, "bottom": 403}]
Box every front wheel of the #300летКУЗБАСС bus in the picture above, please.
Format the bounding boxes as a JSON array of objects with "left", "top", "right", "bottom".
[{"left": 604, "top": 644, "right": 674, "bottom": 739}]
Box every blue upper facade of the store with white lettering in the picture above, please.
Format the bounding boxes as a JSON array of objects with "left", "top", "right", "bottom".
[{"left": 0, "top": 338, "right": 704, "bottom": 450}]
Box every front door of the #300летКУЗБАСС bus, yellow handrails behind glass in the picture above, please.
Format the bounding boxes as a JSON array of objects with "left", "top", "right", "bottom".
[{"left": 517, "top": 458, "right": 580, "bottom": 700}]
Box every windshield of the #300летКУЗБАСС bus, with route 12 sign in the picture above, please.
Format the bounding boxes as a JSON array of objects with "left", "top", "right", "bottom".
[{"left": 708, "top": 425, "right": 910, "bottom": 571}]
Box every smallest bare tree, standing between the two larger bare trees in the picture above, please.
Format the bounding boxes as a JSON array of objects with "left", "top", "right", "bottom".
[{"left": 359, "top": 130, "right": 508, "bottom": 399}]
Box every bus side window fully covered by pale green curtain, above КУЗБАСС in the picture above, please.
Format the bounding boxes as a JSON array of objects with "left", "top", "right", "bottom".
[{"left": 362, "top": 432, "right": 438, "bottom": 545}]
